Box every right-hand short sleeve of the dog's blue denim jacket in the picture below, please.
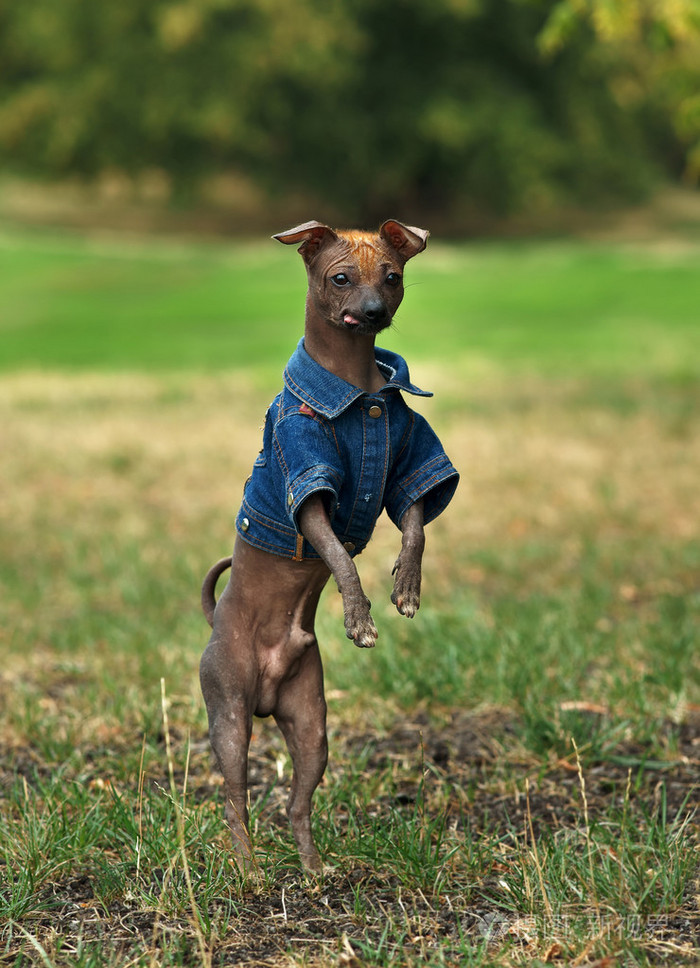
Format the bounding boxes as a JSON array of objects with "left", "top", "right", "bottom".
[{"left": 384, "top": 411, "right": 459, "bottom": 527}]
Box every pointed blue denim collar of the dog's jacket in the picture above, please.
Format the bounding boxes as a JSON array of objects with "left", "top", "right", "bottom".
[{"left": 284, "top": 337, "right": 432, "bottom": 420}]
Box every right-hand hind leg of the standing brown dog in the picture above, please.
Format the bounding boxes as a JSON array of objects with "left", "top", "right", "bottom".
[{"left": 274, "top": 643, "right": 328, "bottom": 871}]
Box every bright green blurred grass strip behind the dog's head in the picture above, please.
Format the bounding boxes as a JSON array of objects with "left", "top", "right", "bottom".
[{"left": 0, "top": 232, "right": 700, "bottom": 379}]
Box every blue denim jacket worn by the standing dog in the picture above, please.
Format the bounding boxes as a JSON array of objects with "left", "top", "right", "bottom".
[{"left": 236, "top": 339, "right": 459, "bottom": 561}]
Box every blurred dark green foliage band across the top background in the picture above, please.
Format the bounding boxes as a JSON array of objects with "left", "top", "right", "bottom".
[{"left": 0, "top": 0, "right": 697, "bottom": 224}]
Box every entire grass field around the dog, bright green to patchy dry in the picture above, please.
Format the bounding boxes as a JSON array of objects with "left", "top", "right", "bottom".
[{"left": 0, "top": 223, "right": 700, "bottom": 968}]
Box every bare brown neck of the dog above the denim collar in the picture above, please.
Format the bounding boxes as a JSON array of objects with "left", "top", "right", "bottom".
[{"left": 304, "top": 300, "right": 386, "bottom": 393}]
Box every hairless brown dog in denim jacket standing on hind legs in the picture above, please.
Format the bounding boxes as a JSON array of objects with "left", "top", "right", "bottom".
[{"left": 200, "top": 220, "right": 459, "bottom": 871}]
